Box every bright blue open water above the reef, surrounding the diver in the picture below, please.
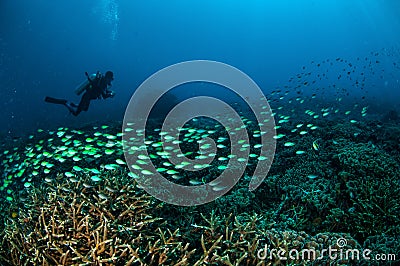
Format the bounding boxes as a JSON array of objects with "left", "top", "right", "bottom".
[{"left": 0, "top": 0, "right": 400, "bottom": 136}]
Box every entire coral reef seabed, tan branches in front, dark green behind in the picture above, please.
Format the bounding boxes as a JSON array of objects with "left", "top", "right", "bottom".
[{"left": 0, "top": 115, "right": 400, "bottom": 265}]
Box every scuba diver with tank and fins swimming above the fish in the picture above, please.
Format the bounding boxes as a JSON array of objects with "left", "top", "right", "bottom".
[{"left": 44, "top": 71, "right": 115, "bottom": 116}]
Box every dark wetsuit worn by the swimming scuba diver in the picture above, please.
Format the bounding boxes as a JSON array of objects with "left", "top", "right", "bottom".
[{"left": 45, "top": 71, "right": 114, "bottom": 116}]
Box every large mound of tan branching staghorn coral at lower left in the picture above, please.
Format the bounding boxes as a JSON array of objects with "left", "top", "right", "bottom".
[{"left": 0, "top": 170, "right": 193, "bottom": 265}]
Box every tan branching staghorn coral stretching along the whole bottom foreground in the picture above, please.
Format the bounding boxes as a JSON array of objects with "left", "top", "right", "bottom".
[{"left": 0, "top": 168, "right": 368, "bottom": 265}]
